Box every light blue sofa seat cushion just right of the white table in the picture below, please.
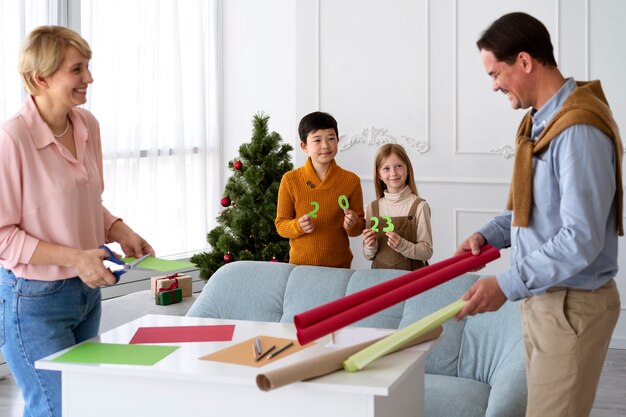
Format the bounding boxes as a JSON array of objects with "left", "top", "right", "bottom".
[{"left": 424, "top": 374, "right": 492, "bottom": 417}]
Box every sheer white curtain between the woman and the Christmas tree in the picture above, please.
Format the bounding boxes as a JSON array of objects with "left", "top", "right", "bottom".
[{"left": 80, "top": 0, "right": 220, "bottom": 258}]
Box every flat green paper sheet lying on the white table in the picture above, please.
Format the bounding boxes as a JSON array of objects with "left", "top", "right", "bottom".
[{"left": 52, "top": 343, "right": 179, "bottom": 366}]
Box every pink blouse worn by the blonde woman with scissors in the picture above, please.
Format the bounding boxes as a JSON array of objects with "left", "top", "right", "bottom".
[{"left": 0, "top": 96, "right": 118, "bottom": 281}]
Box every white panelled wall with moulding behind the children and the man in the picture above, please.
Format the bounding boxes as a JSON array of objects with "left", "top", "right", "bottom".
[{"left": 222, "top": 0, "right": 626, "bottom": 348}]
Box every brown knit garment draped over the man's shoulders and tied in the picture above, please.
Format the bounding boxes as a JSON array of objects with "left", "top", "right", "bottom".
[{"left": 507, "top": 81, "right": 624, "bottom": 236}]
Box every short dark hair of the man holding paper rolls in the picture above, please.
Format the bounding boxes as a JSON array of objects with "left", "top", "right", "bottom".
[{"left": 476, "top": 12, "right": 557, "bottom": 67}]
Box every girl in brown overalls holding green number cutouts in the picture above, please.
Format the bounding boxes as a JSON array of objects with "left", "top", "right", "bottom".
[{"left": 363, "top": 144, "right": 433, "bottom": 271}]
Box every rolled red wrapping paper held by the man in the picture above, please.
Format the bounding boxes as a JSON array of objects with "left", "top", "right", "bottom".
[{"left": 294, "top": 245, "right": 500, "bottom": 344}]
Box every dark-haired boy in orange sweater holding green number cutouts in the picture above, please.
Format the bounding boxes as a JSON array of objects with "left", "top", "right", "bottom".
[{"left": 275, "top": 112, "right": 365, "bottom": 268}]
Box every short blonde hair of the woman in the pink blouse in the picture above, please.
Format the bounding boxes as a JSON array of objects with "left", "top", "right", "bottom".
[{"left": 18, "top": 26, "right": 91, "bottom": 95}]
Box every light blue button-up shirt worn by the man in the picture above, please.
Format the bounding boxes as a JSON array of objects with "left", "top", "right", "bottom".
[{"left": 479, "top": 78, "right": 617, "bottom": 300}]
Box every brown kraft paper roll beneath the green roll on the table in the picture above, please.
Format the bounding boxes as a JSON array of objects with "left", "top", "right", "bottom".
[{"left": 256, "top": 326, "right": 443, "bottom": 391}]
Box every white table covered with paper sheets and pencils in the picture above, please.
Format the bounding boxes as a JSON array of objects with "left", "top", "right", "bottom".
[{"left": 35, "top": 315, "right": 436, "bottom": 417}]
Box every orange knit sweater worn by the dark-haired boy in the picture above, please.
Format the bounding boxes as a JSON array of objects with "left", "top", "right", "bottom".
[{"left": 275, "top": 158, "right": 365, "bottom": 268}]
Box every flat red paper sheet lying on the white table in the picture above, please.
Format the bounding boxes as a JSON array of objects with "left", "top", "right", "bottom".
[{"left": 129, "top": 324, "right": 235, "bottom": 344}]
